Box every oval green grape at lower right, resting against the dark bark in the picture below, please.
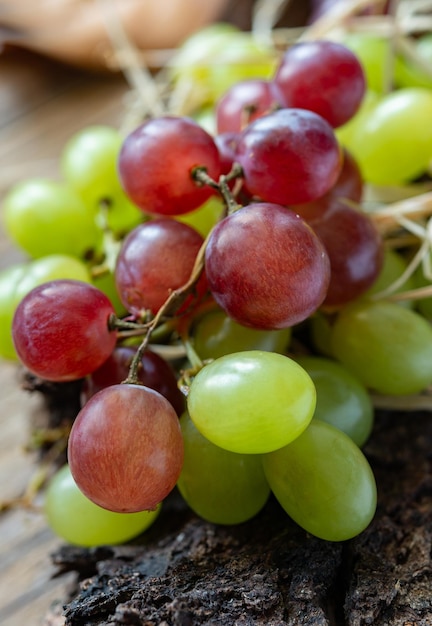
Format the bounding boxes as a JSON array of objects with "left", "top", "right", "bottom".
[{"left": 263, "top": 420, "right": 377, "bottom": 541}]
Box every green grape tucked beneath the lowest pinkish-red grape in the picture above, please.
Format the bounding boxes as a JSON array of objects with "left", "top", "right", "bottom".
[{"left": 44, "top": 465, "right": 161, "bottom": 547}]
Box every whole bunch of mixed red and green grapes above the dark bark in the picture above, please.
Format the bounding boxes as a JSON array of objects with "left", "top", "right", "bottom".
[{"left": 0, "top": 33, "right": 432, "bottom": 545}]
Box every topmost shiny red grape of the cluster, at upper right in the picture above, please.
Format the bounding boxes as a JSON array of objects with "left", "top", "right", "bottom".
[{"left": 274, "top": 40, "right": 366, "bottom": 128}]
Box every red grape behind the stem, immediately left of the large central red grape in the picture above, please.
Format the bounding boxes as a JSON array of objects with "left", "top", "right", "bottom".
[{"left": 115, "top": 218, "right": 207, "bottom": 315}]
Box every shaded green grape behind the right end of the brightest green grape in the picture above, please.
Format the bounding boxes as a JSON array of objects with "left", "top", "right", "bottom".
[{"left": 296, "top": 356, "right": 374, "bottom": 447}]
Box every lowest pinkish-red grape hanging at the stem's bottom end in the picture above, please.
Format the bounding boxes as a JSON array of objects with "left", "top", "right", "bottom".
[{"left": 68, "top": 384, "right": 183, "bottom": 513}]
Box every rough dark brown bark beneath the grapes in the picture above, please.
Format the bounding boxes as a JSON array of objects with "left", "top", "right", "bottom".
[{"left": 47, "top": 412, "right": 432, "bottom": 626}]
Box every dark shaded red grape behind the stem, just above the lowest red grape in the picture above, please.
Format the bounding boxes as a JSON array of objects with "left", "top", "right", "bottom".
[{"left": 81, "top": 346, "right": 185, "bottom": 416}]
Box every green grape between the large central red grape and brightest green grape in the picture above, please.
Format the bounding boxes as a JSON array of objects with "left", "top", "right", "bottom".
[{"left": 193, "top": 310, "right": 291, "bottom": 359}]
